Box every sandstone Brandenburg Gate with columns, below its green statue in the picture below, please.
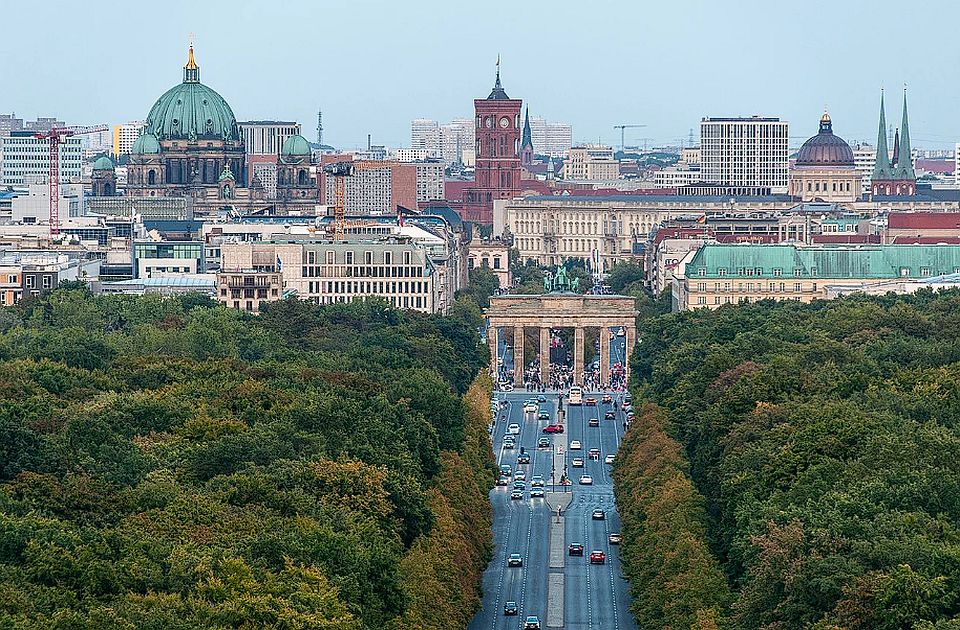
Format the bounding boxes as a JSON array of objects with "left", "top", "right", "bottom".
[{"left": 486, "top": 292, "right": 637, "bottom": 385}]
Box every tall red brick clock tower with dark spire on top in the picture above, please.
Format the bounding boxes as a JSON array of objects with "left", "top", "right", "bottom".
[{"left": 461, "top": 60, "right": 522, "bottom": 225}]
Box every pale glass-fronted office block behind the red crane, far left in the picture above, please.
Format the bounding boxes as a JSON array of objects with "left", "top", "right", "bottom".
[{"left": 0, "top": 131, "right": 83, "bottom": 186}]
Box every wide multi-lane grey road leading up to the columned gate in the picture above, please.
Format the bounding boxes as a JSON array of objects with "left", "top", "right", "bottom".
[{"left": 470, "top": 390, "right": 636, "bottom": 630}]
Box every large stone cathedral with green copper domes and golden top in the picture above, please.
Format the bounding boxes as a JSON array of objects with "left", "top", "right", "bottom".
[{"left": 126, "top": 45, "right": 319, "bottom": 215}]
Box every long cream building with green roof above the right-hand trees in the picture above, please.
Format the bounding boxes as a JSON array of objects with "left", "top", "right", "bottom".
[{"left": 673, "top": 243, "right": 960, "bottom": 311}]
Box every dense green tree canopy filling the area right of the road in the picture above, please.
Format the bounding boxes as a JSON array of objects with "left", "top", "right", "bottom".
[{"left": 616, "top": 291, "right": 960, "bottom": 630}]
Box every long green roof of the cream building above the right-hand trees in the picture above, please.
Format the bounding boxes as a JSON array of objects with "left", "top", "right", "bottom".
[{"left": 686, "top": 244, "right": 960, "bottom": 280}]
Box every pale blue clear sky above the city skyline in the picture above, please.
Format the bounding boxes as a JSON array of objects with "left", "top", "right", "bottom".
[{"left": 0, "top": 0, "right": 960, "bottom": 148}]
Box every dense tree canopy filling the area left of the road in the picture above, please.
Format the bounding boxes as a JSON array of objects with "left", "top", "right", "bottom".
[{"left": 0, "top": 289, "right": 492, "bottom": 630}]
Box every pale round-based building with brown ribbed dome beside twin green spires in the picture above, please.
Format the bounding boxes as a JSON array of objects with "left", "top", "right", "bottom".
[{"left": 790, "top": 112, "right": 860, "bottom": 203}]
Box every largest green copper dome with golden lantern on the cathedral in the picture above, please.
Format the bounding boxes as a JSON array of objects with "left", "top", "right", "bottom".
[{"left": 145, "top": 46, "right": 240, "bottom": 141}]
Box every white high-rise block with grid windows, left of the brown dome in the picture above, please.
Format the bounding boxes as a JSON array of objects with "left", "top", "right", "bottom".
[{"left": 700, "top": 116, "right": 789, "bottom": 194}]
